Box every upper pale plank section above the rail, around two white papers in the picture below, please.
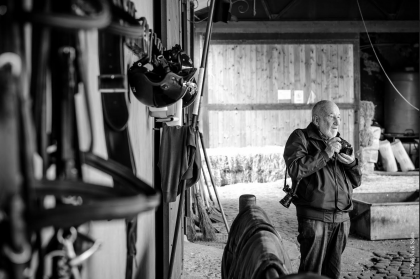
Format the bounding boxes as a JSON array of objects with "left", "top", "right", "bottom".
[{"left": 207, "top": 44, "right": 354, "bottom": 104}]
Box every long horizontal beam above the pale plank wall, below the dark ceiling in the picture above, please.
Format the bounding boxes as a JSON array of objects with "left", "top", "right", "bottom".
[{"left": 196, "top": 20, "right": 419, "bottom": 34}]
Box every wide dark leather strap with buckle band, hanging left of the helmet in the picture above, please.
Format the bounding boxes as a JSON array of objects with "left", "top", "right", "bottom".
[{"left": 99, "top": 12, "right": 142, "bottom": 279}]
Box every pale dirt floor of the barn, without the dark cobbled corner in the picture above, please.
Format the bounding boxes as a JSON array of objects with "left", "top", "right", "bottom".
[{"left": 182, "top": 173, "right": 419, "bottom": 279}]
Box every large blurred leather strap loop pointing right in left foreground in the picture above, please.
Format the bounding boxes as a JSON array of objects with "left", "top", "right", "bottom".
[{"left": 29, "top": 153, "right": 160, "bottom": 229}]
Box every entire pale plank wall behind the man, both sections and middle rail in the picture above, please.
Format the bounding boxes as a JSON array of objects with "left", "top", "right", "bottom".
[{"left": 207, "top": 43, "right": 355, "bottom": 147}]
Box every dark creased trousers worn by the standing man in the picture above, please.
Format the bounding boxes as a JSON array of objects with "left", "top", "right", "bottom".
[{"left": 297, "top": 217, "right": 350, "bottom": 279}]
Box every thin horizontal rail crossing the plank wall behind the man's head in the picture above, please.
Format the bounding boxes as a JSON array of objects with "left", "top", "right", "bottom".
[{"left": 207, "top": 103, "right": 356, "bottom": 111}]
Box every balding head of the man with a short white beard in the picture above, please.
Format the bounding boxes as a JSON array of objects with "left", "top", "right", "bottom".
[{"left": 315, "top": 103, "right": 341, "bottom": 139}]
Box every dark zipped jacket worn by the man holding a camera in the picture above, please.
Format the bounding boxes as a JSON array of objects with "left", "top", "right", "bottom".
[{"left": 283, "top": 123, "right": 362, "bottom": 222}]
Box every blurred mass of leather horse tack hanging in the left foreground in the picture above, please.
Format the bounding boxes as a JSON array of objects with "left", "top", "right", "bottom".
[{"left": 0, "top": 0, "right": 160, "bottom": 279}]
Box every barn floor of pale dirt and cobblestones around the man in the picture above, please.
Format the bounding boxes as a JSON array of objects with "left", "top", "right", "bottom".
[{"left": 182, "top": 175, "right": 419, "bottom": 279}]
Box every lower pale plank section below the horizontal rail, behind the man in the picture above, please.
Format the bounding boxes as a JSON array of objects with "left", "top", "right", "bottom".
[{"left": 209, "top": 109, "right": 354, "bottom": 148}]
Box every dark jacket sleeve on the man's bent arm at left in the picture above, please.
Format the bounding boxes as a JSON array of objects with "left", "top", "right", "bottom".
[{"left": 283, "top": 129, "right": 330, "bottom": 180}]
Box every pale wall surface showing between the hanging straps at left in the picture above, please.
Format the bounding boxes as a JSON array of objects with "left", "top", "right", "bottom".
[{"left": 84, "top": 0, "right": 156, "bottom": 279}]
